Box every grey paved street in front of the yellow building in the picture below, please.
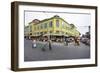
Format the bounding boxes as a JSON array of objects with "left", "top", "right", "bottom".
[{"left": 24, "top": 39, "right": 90, "bottom": 61}]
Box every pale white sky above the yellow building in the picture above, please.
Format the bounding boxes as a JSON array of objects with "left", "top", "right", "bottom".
[{"left": 24, "top": 11, "right": 91, "bottom": 34}]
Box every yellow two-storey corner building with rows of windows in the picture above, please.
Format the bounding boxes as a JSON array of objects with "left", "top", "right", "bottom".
[{"left": 24, "top": 15, "right": 80, "bottom": 40}]
